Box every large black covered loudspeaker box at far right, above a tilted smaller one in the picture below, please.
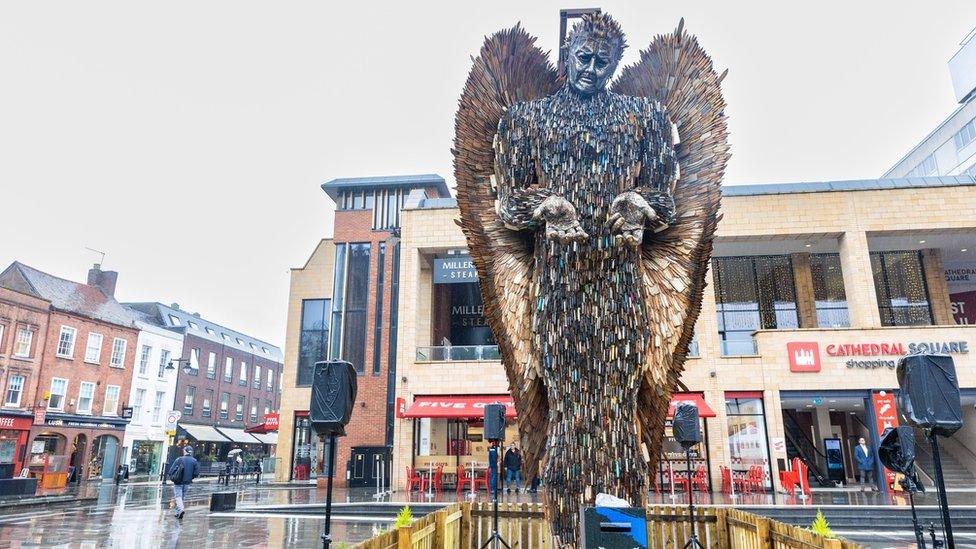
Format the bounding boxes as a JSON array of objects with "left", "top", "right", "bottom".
[{"left": 896, "top": 354, "right": 962, "bottom": 437}]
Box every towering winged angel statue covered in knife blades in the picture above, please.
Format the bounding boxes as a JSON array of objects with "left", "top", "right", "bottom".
[{"left": 454, "top": 14, "right": 729, "bottom": 545}]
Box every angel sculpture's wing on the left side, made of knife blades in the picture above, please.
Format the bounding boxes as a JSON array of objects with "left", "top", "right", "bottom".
[{"left": 453, "top": 25, "right": 558, "bottom": 478}]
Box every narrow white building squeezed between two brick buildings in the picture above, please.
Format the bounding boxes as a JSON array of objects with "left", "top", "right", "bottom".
[{"left": 122, "top": 309, "right": 183, "bottom": 478}]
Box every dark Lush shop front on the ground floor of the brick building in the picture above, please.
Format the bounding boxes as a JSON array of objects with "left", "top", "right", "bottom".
[{"left": 29, "top": 412, "right": 128, "bottom": 482}]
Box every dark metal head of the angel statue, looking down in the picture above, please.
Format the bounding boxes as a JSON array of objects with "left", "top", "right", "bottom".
[{"left": 563, "top": 13, "right": 627, "bottom": 95}]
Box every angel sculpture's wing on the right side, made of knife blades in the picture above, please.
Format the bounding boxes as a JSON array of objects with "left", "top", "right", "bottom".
[{"left": 613, "top": 20, "right": 730, "bottom": 463}]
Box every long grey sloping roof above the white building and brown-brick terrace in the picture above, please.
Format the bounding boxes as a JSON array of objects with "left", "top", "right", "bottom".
[{"left": 124, "top": 301, "right": 284, "bottom": 362}]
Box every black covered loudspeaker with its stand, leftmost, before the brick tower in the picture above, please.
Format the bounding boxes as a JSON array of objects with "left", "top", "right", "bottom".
[{"left": 308, "top": 360, "right": 357, "bottom": 549}]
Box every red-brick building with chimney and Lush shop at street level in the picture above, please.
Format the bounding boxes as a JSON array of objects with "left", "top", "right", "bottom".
[{"left": 0, "top": 262, "right": 138, "bottom": 479}]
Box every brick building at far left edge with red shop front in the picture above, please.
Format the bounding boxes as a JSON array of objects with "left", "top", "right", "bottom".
[{"left": 0, "top": 282, "right": 51, "bottom": 478}]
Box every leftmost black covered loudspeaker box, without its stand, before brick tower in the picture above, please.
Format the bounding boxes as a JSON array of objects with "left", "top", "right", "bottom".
[{"left": 308, "top": 360, "right": 356, "bottom": 437}]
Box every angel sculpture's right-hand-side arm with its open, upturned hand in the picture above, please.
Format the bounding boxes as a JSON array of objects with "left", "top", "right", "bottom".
[{"left": 608, "top": 105, "right": 678, "bottom": 246}]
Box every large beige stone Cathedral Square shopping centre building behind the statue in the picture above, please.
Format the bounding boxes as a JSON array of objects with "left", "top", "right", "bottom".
[{"left": 279, "top": 171, "right": 976, "bottom": 488}]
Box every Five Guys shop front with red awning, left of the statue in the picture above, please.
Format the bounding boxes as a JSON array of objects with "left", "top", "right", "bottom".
[{"left": 398, "top": 395, "right": 518, "bottom": 483}]
